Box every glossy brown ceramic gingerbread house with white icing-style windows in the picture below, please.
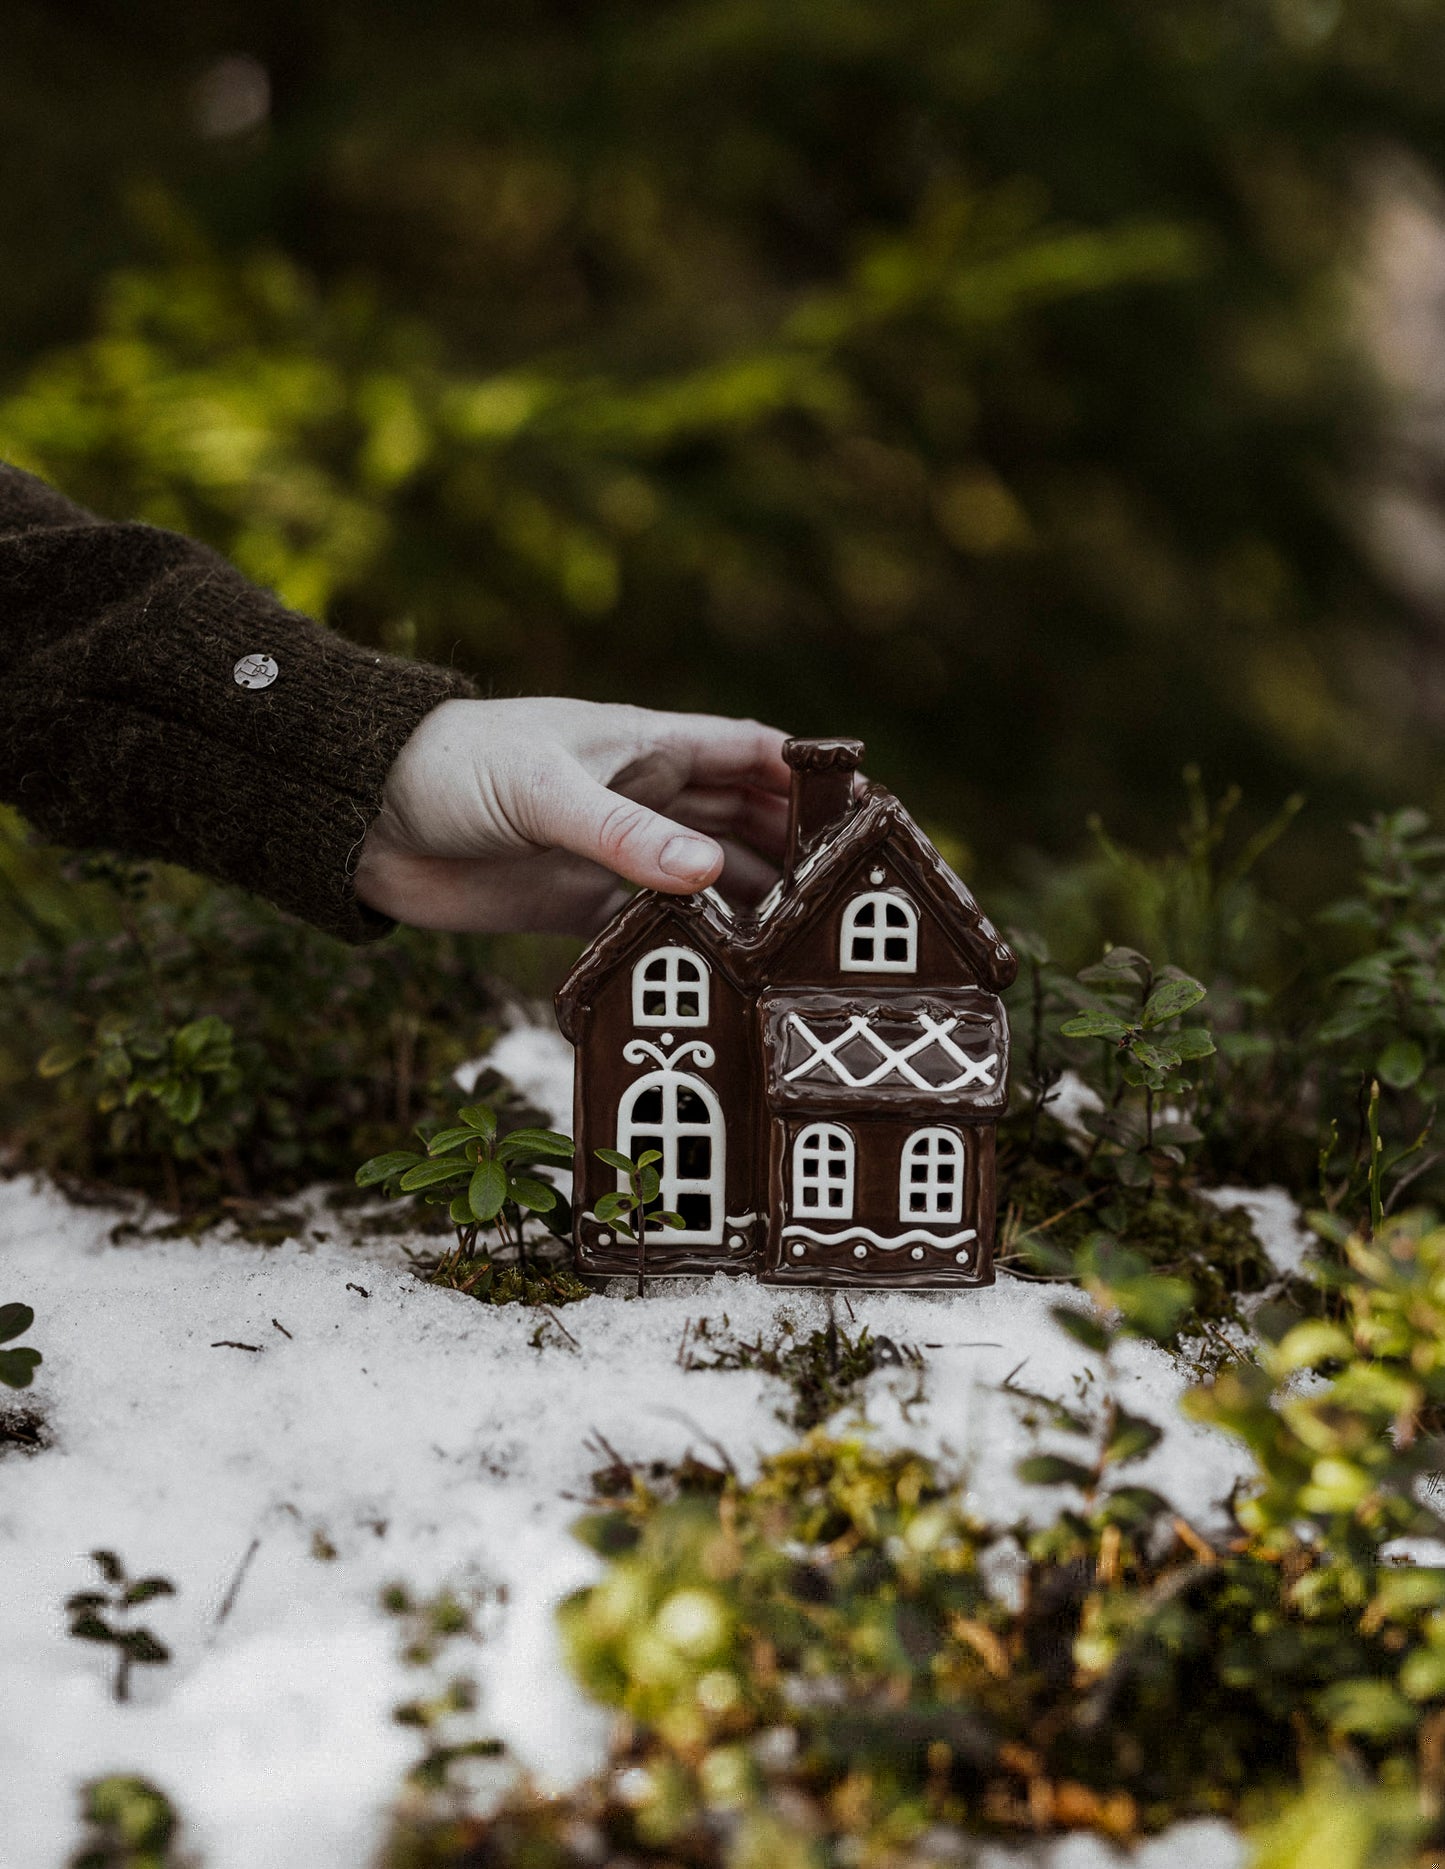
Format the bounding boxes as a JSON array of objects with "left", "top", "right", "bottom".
[{"left": 557, "top": 740, "right": 1017, "bottom": 1288}]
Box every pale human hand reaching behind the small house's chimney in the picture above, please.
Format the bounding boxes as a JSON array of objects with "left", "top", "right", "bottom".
[{"left": 355, "top": 699, "right": 791, "bottom": 935}]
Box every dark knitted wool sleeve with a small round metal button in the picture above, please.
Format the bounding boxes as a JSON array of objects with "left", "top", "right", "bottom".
[{"left": 0, "top": 464, "right": 471, "bottom": 940}]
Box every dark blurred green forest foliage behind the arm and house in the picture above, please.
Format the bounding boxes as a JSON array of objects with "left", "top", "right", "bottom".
[{"left": 0, "top": 0, "right": 1445, "bottom": 893}]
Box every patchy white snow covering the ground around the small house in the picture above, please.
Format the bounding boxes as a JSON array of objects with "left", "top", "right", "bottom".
[{"left": 0, "top": 1028, "right": 1271, "bottom": 1869}]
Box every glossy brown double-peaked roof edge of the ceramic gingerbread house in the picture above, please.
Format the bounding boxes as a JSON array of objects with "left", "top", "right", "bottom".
[{"left": 557, "top": 785, "right": 1019, "bottom": 1039}]
